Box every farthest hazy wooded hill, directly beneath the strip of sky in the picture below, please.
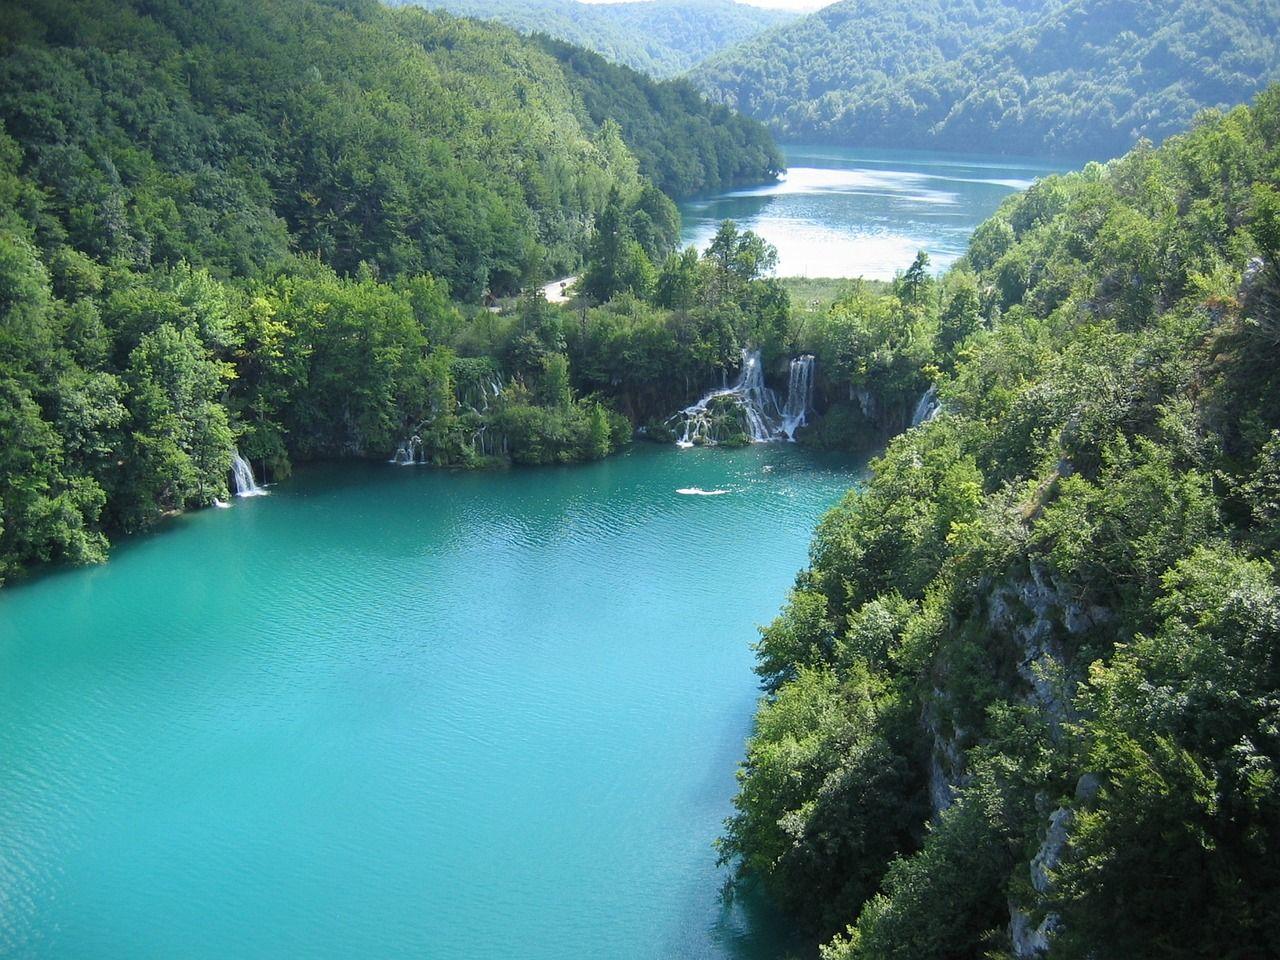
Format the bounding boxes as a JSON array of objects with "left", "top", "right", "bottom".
[{"left": 396, "top": 0, "right": 795, "bottom": 79}]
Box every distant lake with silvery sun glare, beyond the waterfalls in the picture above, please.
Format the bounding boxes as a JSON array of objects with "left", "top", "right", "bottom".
[{"left": 680, "top": 145, "right": 1065, "bottom": 280}]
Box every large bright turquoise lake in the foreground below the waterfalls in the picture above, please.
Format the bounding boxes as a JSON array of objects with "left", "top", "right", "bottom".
[{"left": 0, "top": 444, "right": 860, "bottom": 960}]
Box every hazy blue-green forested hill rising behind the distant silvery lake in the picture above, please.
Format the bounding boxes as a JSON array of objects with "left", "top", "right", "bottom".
[{"left": 690, "top": 0, "right": 1280, "bottom": 157}]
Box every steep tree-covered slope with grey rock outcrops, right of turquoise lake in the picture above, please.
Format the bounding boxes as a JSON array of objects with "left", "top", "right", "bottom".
[{"left": 722, "top": 87, "right": 1280, "bottom": 960}]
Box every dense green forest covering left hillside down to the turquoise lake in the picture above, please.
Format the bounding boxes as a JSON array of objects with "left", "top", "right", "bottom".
[{"left": 0, "top": 0, "right": 778, "bottom": 576}]
